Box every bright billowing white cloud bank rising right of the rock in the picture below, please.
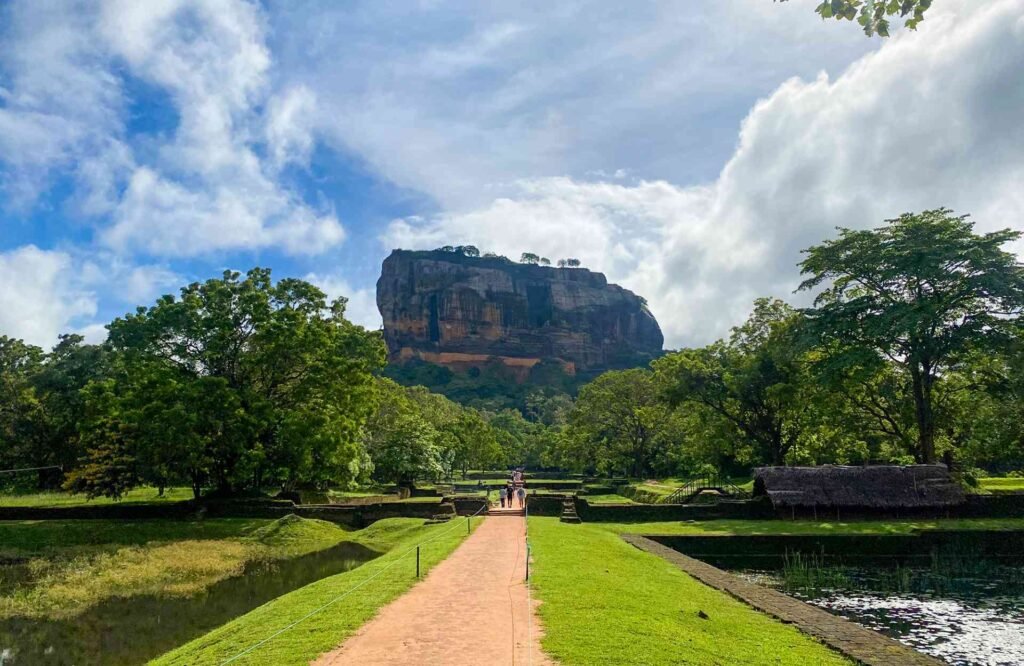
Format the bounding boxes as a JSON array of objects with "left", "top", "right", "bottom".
[{"left": 384, "top": 0, "right": 1024, "bottom": 346}]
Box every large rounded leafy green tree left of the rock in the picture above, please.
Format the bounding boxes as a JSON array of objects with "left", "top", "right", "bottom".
[{"left": 72, "top": 268, "right": 384, "bottom": 494}]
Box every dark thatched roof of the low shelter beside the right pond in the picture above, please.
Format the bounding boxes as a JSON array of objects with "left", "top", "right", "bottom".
[{"left": 754, "top": 465, "right": 965, "bottom": 509}]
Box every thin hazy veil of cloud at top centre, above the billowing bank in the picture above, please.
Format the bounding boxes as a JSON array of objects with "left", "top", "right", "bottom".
[{"left": 270, "top": 0, "right": 879, "bottom": 209}]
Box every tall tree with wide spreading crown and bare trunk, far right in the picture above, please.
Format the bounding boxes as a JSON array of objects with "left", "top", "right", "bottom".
[{"left": 800, "top": 208, "right": 1024, "bottom": 462}]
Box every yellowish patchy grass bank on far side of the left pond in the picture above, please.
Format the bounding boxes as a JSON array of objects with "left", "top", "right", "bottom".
[{"left": 0, "top": 515, "right": 360, "bottom": 619}]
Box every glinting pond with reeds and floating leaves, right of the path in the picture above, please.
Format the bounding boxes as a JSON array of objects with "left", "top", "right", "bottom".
[{"left": 734, "top": 566, "right": 1024, "bottom": 666}]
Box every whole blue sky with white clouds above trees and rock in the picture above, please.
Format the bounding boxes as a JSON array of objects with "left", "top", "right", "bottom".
[{"left": 0, "top": 0, "right": 1024, "bottom": 346}]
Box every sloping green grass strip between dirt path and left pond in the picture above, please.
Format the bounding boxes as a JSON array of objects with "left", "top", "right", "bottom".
[{"left": 152, "top": 518, "right": 481, "bottom": 666}]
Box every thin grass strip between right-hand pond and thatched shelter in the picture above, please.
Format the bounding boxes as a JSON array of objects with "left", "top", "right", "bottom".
[{"left": 588, "top": 518, "right": 1024, "bottom": 535}]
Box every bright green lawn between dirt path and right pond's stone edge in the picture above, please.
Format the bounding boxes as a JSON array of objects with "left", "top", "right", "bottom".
[{"left": 529, "top": 517, "right": 850, "bottom": 666}]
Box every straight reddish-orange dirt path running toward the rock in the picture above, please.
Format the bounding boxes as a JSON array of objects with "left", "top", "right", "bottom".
[{"left": 313, "top": 506, "right": 553, "bottom": 666}]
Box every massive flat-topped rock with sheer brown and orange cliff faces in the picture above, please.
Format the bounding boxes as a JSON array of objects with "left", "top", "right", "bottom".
[{"left": 377, "top": 250, "right": 664, "bottom": 373}]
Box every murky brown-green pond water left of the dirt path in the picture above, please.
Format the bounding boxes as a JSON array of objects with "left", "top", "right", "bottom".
[{"left": 0, "top": 543, "right": 379, "bottom": 666}]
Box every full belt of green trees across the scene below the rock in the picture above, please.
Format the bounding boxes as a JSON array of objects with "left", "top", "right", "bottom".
[{"left": 0, "top": 209, "right": 1024, "bottom": 497}]
